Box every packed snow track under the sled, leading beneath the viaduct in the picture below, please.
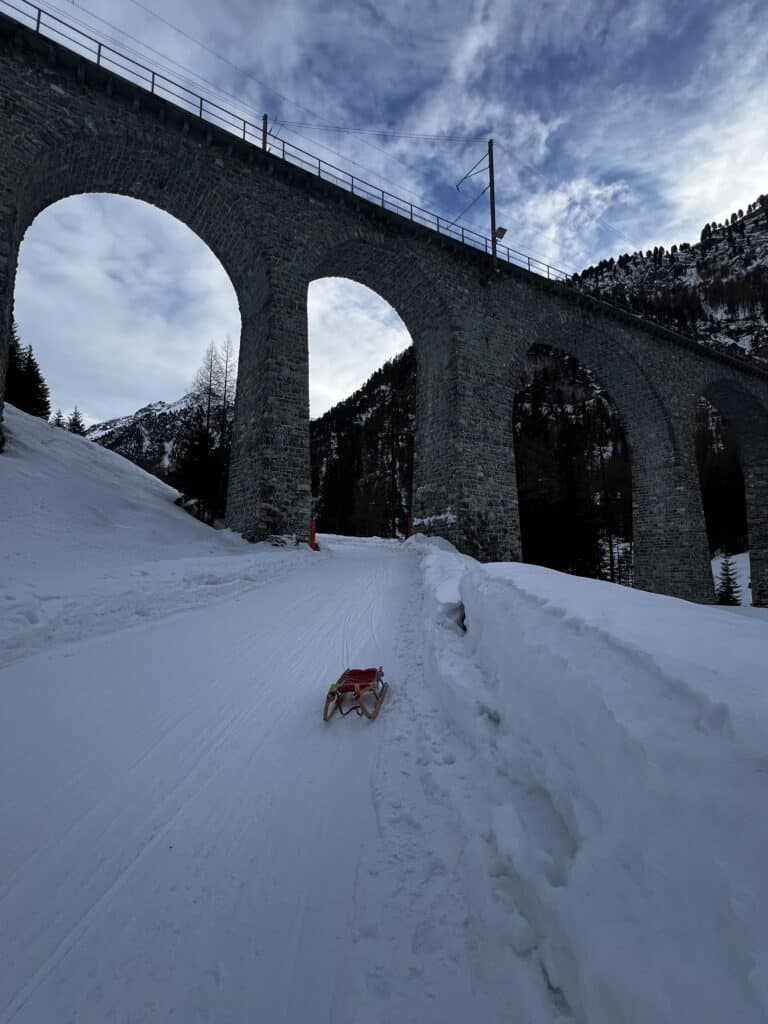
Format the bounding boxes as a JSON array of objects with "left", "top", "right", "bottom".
[{"left": 0, "top": 542, "right": 552, "bottom": 1024}]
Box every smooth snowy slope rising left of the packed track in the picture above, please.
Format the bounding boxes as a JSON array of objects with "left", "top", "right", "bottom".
[{"left": 0, "top": 406, "right": 315, "bottom": 665}]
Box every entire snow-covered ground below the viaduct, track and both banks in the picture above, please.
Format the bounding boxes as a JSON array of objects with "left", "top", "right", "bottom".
[{"left": 0, "top": 409, "right": 768, "bottom": 1024}]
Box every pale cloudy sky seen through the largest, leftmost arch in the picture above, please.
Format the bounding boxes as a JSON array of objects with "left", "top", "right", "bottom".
[{"left": 14, "top": 194, "right": 240, "bottom": 420}]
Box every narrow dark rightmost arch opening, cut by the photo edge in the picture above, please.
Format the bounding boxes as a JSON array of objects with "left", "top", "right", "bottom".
[{"left": 695, "top": 381, "right": 768, "bottom": 604}]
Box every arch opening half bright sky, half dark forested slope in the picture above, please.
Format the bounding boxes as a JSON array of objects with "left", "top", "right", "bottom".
[{"left": 307, "top": 275, "right": 416, "bottom": 537}]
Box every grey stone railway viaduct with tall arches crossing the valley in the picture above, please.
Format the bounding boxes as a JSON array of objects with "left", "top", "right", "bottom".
[{"left": 0, "top": 9, "right": 768, "bottom": 604}]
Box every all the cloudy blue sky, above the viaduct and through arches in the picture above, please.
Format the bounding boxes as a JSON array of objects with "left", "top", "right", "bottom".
[{"left": 10, "top": 0, "right": 768, "bottom": 422}]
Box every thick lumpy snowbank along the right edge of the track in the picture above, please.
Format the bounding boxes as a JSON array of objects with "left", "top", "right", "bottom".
[{"left": 415, "top": 539, "right": 768, "bottom": 1024}]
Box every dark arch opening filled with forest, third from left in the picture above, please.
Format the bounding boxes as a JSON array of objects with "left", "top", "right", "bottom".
[{"left": 513, "top": 344, "right": 634, "bottom": 586}]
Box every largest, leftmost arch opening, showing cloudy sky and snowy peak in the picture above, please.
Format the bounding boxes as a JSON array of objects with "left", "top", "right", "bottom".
[{"left": 7, "top": 193, "right": 241, "bottom": 518}]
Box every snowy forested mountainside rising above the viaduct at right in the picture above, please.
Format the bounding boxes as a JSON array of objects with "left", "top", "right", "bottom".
[{"left": 575, "top": 196, "right": 768, "bottom": 359}]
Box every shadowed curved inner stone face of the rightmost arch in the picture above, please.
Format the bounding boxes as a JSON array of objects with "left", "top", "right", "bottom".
[{"left": 700, "top": 375, "right": 768, "bottom": 607}]
